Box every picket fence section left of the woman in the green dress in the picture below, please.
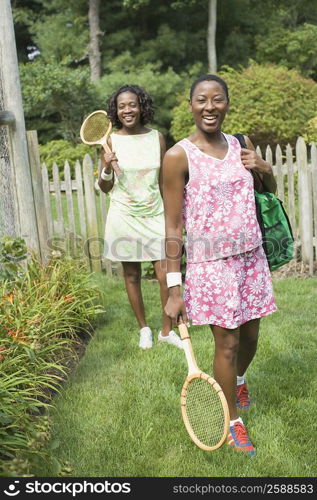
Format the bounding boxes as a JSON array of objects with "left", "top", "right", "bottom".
[{"left": 41, "top": 155, "right": 118, "bottom": 275}]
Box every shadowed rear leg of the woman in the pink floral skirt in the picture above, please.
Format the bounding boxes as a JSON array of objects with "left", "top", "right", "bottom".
[{"left": 237, "top": 318, "right": 260, "bottom": 377}]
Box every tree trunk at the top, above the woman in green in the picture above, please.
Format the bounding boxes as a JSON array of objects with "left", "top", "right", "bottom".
[{"left": 88, "top": 0, "right": 101, "bottom": 82}]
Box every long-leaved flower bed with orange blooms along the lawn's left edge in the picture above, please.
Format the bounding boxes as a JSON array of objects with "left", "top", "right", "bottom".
[{"left": 0, "top": 241, "right": 100, "bottom": 477}]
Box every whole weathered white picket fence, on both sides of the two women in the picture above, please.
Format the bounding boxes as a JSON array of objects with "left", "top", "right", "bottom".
[{"left": 28, "top": 132, "right": 317, "bottom": 275}]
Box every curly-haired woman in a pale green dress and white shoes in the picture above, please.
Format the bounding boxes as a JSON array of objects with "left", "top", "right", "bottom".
[{"left": 98, "top": 85, "right": 182, "bottom": 349}]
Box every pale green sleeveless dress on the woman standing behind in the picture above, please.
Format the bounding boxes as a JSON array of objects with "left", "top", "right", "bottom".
[{"left": 104, "top": 129, "right": 165, "bottom": 262}]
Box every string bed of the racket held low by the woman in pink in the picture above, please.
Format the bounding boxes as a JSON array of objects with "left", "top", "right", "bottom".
[{"left": 186, "top": 378, "right": 225, "bottom": 447}]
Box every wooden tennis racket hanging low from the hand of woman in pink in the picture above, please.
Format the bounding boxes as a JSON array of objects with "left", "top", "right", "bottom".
[{"left": 178, "top": 323, "right": 230, "bottom": 451}]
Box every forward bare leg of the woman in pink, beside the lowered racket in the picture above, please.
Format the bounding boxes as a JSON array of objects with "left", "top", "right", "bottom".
[{"left": 211, "top": 325, "right": 239, "bottom": 420}]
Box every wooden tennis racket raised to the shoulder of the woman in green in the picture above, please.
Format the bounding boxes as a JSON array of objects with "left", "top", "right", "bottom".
[{"left": 80, "top": 109, "right": 123, "bottom": 177}]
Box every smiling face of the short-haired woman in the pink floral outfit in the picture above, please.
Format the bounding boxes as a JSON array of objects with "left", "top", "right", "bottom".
[{"left": 190, "top": 80, "right": 229, "bottom": 133}]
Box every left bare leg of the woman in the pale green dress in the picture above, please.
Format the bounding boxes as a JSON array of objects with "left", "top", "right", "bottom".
[{"left": 122, "top": 262, "right": 146, "bottom": 328}]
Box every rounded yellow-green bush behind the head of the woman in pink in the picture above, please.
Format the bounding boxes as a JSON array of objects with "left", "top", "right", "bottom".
[{"left": 171, "top": 62, "right": 317, "bottom": 147}]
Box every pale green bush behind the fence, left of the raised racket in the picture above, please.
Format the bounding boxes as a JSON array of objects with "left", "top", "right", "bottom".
[{"left": 19, "top": 57, "right": 99, "bottom": 144}]
